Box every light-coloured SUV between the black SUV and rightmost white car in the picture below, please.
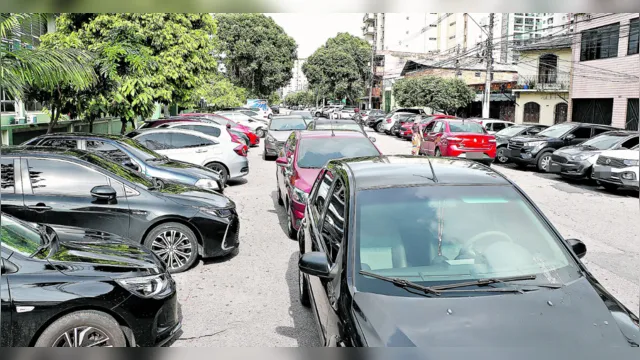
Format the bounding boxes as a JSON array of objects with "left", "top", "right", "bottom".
[{"left": 549, "top": 130, "right": 640, "bottom": 179}]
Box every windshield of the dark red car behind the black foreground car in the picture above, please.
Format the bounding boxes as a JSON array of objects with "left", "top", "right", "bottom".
[{"left": 298, "top": 136, "right": 380, "bottom": 168}]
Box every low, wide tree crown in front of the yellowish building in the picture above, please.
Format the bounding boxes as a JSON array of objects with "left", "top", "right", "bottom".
[{"left": 393, "top": 76, "right": 475, "bottom": 114}]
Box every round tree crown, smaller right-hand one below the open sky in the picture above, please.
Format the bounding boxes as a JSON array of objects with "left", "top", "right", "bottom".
[{"left": 302, "top": 33, "right": 371, "bottom": 102}]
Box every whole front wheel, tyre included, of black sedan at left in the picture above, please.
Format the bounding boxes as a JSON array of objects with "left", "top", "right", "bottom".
[{"left": 144, "top": 222, "right": 198, "bottom": 274}]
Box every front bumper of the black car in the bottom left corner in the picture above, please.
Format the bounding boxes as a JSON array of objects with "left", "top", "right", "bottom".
[{"left": 112, "top": 280, "right": 182, "bottom": 347}]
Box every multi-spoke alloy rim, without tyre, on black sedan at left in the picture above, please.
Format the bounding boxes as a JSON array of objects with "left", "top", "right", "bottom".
[{"left": 151, "top": 230, "right": 195, "bottom": 269}]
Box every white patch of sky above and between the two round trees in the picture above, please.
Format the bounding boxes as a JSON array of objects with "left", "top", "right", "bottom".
[{"left": 265, "top": 13, "right": 364, "bottom": 59}]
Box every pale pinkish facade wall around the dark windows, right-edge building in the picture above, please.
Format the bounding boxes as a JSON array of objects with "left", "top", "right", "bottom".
[{"left": 568, "top": 13, "right": 640, "bottom": 128}]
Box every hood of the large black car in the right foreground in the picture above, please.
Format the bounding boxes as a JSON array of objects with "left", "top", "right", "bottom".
[{"left": 354, "top": 278, "right": 640, "bottom": 348}]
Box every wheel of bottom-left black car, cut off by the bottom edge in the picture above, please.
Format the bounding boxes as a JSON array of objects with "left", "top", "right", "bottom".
[{"left": 35, "top": 310, "right": 127, "bottom": 347}]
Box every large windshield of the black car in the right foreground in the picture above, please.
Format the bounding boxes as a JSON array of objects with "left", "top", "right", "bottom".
[{"left": 354, "top": 186, "right": 579, "bottom": 296}]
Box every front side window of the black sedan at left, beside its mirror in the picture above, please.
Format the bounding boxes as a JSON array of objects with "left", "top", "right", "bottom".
[{"left": 28, "top": 159, "right": 109, "bottom": 197}]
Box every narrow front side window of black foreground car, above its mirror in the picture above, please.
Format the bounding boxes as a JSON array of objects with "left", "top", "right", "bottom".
[{"left": 322, "top": 179, "right": 346, "bottom": 263}]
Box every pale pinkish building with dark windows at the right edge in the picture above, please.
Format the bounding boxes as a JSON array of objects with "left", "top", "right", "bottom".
[{"left": 569, "top": 13, "right": 640, "bottom": 130}]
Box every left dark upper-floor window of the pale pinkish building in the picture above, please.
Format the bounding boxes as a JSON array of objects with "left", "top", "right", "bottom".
[{"left": 580, "top": 23, "right": 620, "bottom": 61}]
